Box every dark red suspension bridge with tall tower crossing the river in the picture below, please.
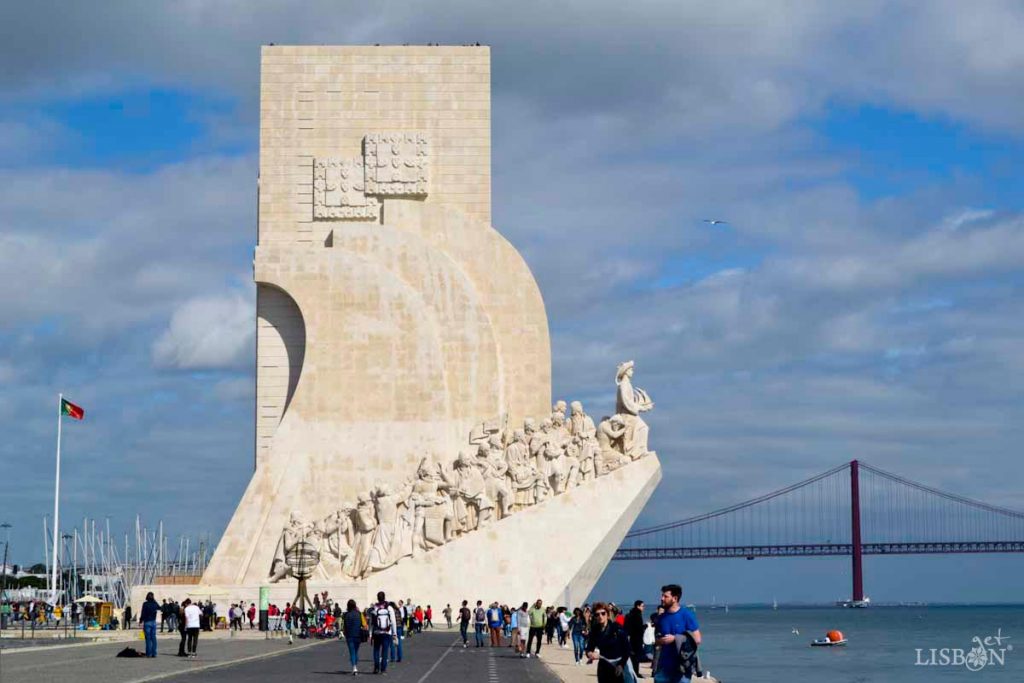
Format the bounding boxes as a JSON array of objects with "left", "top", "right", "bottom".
[{"left": 613, "top": 460, "right": 1024, "bottom": 606}]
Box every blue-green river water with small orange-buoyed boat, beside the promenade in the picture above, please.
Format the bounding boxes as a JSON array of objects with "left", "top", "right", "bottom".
[{"left": 675, "top": 606, "right": 1024, "bottom": 683}]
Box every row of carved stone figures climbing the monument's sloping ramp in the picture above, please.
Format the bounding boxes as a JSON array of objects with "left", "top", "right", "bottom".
[{"left": 269, "top": 360, "right": 654, "bottom": 582}]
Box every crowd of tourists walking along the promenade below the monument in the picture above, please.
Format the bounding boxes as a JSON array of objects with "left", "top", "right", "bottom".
[{"left": 99, "top": 584, "right": 700, "bottom": 683}]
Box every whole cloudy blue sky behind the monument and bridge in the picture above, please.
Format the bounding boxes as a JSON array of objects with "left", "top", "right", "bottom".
[{"left": 0, "top": 0, "right": 1024, "bottom": 602}]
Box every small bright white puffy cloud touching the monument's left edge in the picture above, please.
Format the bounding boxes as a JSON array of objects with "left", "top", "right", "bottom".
[{"left": 153, "top": 294, "right": 256, "bottom": 370}]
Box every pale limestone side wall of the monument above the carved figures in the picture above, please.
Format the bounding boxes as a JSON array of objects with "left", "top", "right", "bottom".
[{"left": 205, "top": 46, "right": 551, "bottom": 583}]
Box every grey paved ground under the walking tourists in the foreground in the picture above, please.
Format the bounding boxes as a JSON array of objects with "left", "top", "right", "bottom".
[{"left": 0, "top": 631, "right": 561, "bottom": 683}]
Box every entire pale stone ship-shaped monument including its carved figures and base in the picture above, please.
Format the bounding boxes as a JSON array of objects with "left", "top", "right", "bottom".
[{"left": 133, "top": 46, "right": 660, "bottom": 605}]
